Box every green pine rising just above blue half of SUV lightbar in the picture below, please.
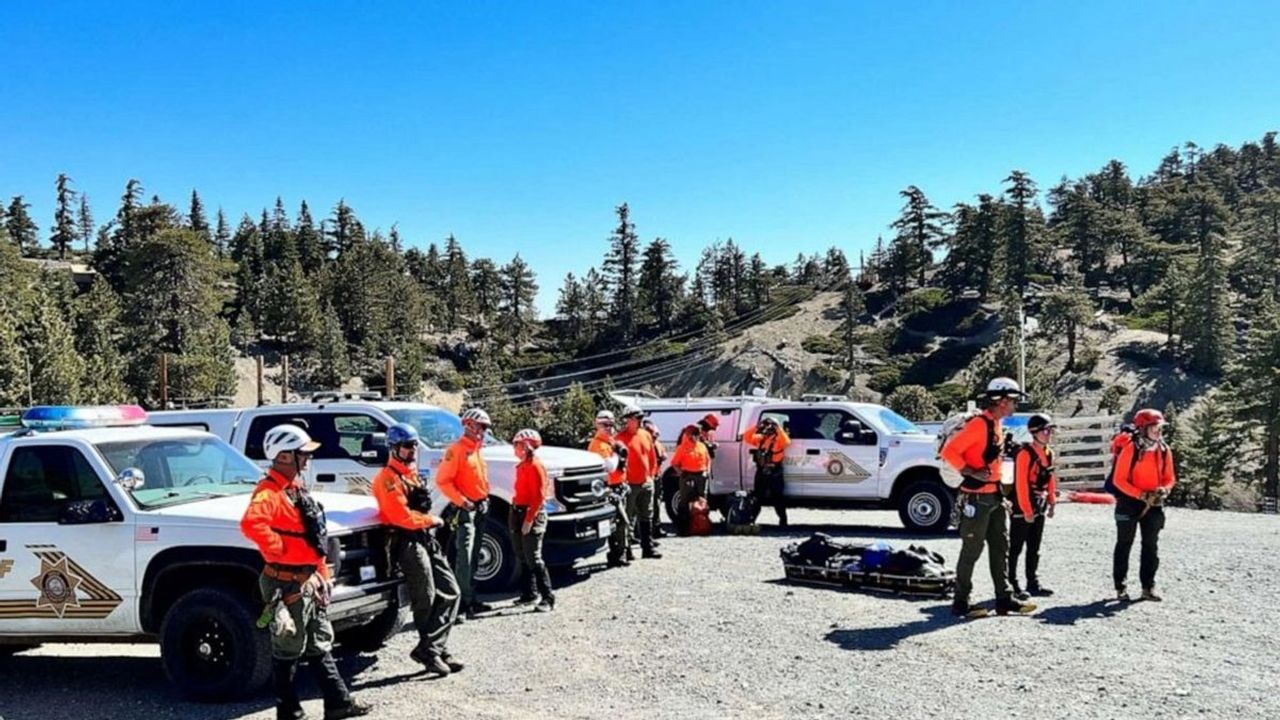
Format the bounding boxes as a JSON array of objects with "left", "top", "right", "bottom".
[{"left": 22, "top": 281, "right": 84, "bottom": 405}]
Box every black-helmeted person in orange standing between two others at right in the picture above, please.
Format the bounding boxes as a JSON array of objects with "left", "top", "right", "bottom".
[{"left": 1009, "top": 413, "right": 1057, "bottom": 600}]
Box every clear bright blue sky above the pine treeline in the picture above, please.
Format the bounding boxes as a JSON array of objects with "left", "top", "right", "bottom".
[{"left": 0, "top": 0, "right": 1280, "bottom": 311}]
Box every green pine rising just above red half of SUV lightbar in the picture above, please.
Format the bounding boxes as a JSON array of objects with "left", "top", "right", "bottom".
[{"left": 74, "top": 278, "right": 128, "bottom": 405}]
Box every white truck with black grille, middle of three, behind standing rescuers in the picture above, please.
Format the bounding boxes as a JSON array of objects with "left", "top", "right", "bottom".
[{"left": 150, "top": 393, "right": 614, "bottom": 591}]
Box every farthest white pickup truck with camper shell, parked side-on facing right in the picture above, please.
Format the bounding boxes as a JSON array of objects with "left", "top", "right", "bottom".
[{"left": 613, "top": 391, "right": 955, "bottom": 533}]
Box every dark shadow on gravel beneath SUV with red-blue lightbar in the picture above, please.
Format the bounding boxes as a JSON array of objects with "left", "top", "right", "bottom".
[{"left": 0, "top": 655, "right": 376, "bottom": 720}]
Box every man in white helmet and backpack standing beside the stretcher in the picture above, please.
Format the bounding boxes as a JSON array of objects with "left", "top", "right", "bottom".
[{"left": 941, "top": 378, "right": 1036, "bottom": 618}]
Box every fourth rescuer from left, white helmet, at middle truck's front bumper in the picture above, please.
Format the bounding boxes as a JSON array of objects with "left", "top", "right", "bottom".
[{"left": 507, "top": 429, "right": 556, "bottom": 612}]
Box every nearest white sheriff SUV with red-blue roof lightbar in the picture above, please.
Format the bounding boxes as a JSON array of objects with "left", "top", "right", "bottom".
[{"left": 0, "top": 406, "right": 407, "bottom": 700}]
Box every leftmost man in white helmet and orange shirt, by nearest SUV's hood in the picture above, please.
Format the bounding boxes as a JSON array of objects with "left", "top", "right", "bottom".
[{"left": 241, "top": 424, "right": 370, "bottom": 720}]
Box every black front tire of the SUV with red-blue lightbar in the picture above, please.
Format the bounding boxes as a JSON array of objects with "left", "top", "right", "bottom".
[{"left": 160, "top": 587, "right": 271, "bottom": 702}]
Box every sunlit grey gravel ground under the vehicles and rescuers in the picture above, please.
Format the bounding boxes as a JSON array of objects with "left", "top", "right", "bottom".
[{"left": 0, "top": 505, "right": 1280, "bottom": 720}]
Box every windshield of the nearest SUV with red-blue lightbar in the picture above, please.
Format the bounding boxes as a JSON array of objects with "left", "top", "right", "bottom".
[{"left": 97, "top": 436, "right": 262, "bottom": 509}]
